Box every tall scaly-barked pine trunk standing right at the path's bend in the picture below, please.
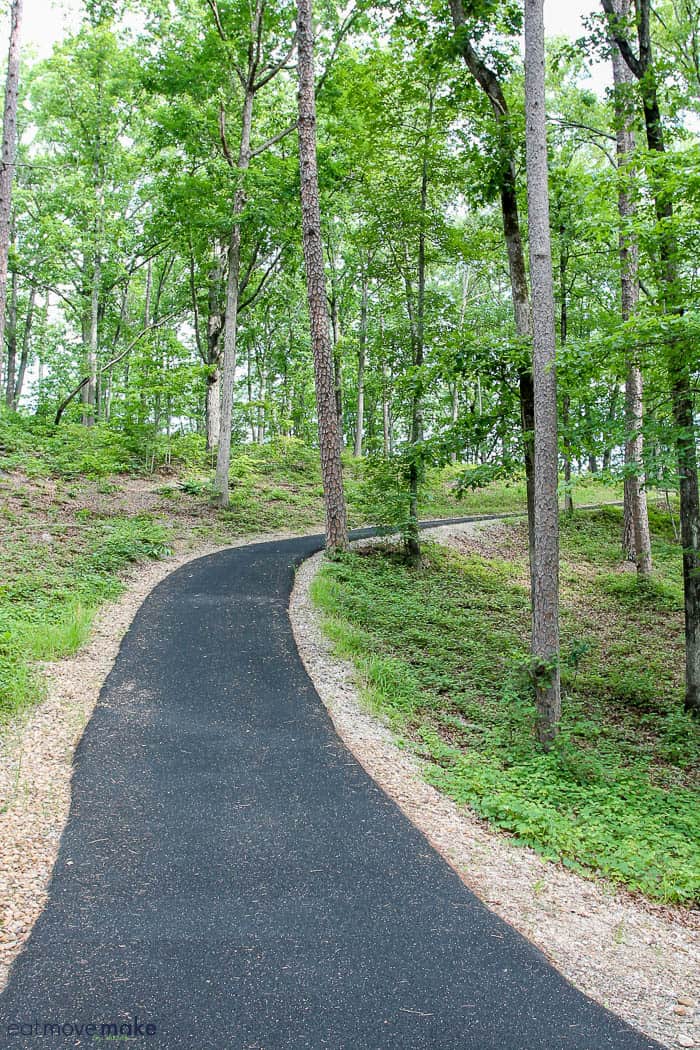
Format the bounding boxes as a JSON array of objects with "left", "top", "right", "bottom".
[{"left": 297, "top": 0, "right": 347, "bottom": 551}]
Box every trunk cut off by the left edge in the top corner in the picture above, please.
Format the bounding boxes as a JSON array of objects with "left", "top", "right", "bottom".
[{"left": 0, "top": 0, "right": 23, "bottom": 385}]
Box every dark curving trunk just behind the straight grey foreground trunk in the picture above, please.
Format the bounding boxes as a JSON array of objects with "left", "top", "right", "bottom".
[{"left": 449, "top": 0, "right": 534, "bottom": 579}]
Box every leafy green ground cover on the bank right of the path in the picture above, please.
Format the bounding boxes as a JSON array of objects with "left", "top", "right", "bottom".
[{"left": 314, "top": 508, "right": 700, "bottom": 904}]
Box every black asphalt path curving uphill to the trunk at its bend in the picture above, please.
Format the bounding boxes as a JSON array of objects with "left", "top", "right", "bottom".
[{"left": 0, "top": 520, "right": 657, "bottom": 1050}]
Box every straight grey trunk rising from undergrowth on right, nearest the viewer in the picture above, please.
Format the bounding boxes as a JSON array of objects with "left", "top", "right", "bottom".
[{"left": 525, "top": 0, "right": 561, "bottom": 748}]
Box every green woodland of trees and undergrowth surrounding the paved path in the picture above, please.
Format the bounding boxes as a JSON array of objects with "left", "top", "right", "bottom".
[{"left": 0, "top": 0, "right": 700, "bottom": 905}]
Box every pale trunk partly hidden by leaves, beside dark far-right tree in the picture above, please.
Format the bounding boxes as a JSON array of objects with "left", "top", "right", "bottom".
[{"left": 612, "top": 0, "right": 652, "bottom": 578}]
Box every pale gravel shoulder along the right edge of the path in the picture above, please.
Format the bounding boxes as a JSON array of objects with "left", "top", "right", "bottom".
[{"left": 290, "top": 523, "right": 700, "bottom": 1047}]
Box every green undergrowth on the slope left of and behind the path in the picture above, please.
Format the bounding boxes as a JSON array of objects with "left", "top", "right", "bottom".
[{"left": 0, "top": 414, "right": 615, "bottom": 723}]
